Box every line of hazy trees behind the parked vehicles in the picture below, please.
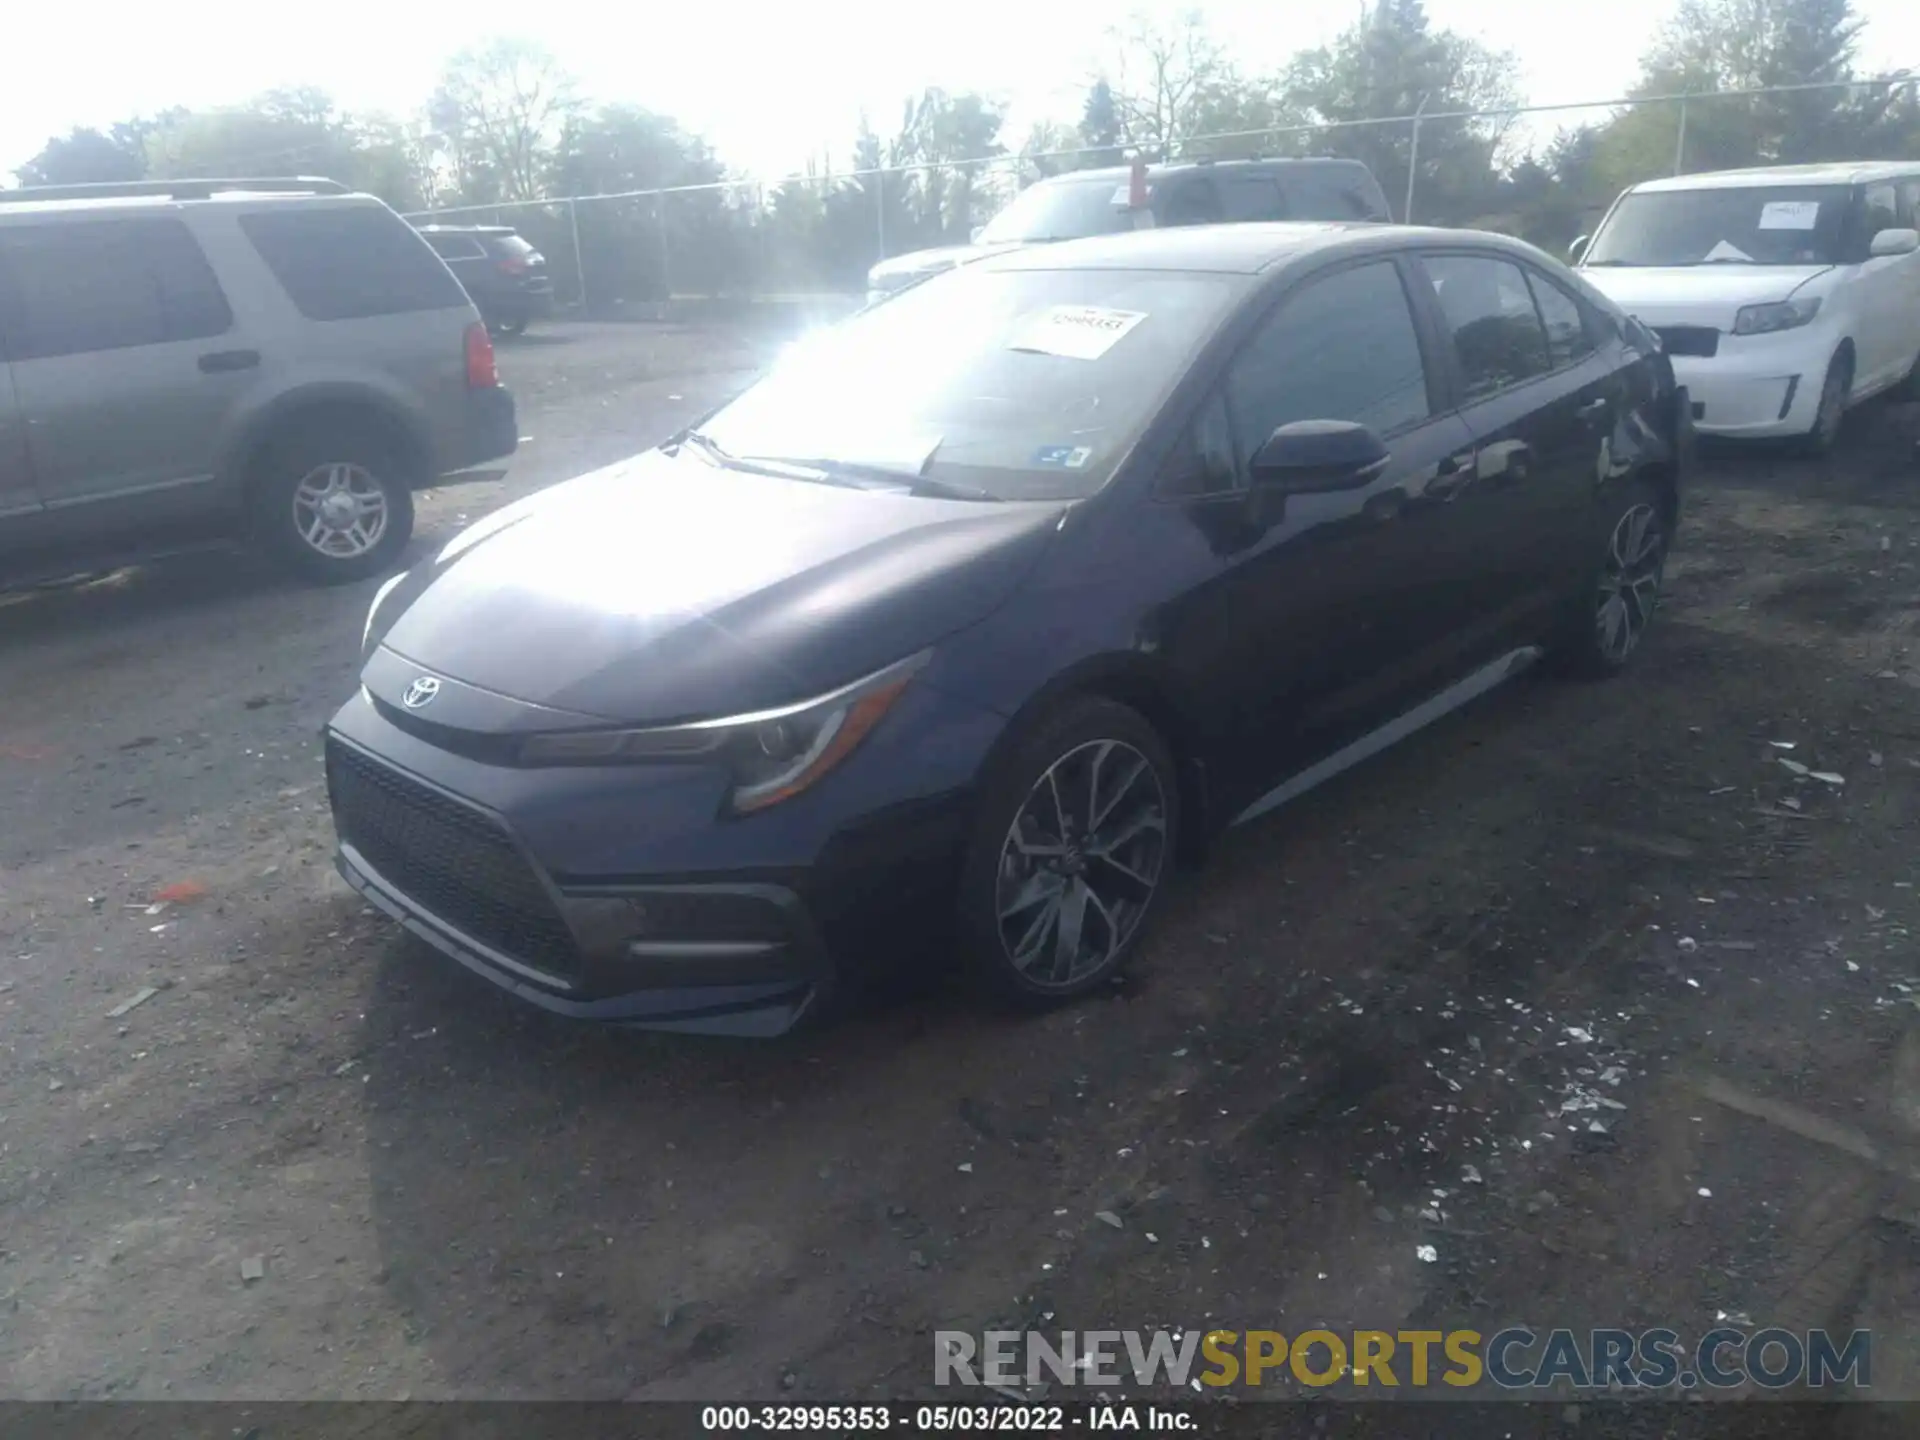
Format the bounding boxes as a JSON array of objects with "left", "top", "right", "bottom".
[{"left": 7, "top": 0, "right": 1920, "bottom": 301}]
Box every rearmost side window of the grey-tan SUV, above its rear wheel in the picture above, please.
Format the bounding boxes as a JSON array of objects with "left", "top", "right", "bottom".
[{"left": 240, "top": 205, "right": 467, "bottom": 321}]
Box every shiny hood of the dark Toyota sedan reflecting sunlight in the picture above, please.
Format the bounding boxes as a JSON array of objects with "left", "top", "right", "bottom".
[{"left": 363, "top": 451, "right": 1066, "bottom": 724}]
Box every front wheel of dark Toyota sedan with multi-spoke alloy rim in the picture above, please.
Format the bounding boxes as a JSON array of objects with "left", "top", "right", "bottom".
[{"left": 960, "top": 695, "right": 1179, "bottom": 1010}]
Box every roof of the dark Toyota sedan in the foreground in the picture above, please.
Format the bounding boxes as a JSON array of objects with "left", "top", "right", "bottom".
[{"left": 970, "top": 221, "right": 1538, "bottom": 275}]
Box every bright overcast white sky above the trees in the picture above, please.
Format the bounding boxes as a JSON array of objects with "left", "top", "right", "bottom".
[{"left": 0, "top": 0, "right": 1920, "bottom": 186}]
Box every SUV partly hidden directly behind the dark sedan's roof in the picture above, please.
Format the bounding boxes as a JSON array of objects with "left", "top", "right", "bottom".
[{"left": 866, "top": 159, "right": 1392, "bottom": 301}]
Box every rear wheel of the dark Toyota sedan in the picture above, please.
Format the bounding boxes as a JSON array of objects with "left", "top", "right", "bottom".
[{"left": 1553, "top": 480, "right": 1672, "bottom": 680}]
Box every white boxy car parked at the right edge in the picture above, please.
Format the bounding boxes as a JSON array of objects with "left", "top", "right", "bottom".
[{"left": 1574, "top": 161, "right": 1920, "bottom": 451}]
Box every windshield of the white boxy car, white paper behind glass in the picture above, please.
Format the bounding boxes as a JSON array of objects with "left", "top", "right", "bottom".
[{"left": 1584, "top": 184, "right": 1849, "bottom": 265}]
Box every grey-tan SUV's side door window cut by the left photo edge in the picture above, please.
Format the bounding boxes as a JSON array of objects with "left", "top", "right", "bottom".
[{"left": 0, "top": 217, "right": 232, "bottom": 361}]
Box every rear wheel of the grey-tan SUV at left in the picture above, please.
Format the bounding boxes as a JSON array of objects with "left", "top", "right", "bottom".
[{"left": 253, "top": 426, "right": 413, "bottom": 586}]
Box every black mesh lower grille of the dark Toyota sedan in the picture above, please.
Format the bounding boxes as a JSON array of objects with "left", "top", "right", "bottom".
[{"left": 326, "top": 739, "right": 580, "bottom": 979}]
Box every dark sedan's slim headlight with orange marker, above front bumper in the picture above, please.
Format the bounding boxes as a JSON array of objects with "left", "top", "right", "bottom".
[{"left": 520, "top": 651, "right": 931, "bottom": 814}]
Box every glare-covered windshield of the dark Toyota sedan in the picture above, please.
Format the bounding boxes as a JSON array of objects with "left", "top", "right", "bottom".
[{"left": 701, "top": 267, "right": 1244, "bottom": 499}]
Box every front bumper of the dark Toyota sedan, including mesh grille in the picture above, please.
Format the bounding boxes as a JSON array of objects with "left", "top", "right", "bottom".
[{"left": 326, "top": 695, "right": 987, "bottom": 1035}]
